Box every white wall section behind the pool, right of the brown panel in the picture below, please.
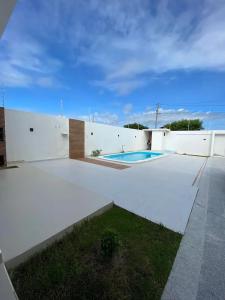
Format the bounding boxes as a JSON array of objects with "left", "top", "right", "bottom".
[{"left": 85, "top": 122, "right": 147, "bottom": 156}]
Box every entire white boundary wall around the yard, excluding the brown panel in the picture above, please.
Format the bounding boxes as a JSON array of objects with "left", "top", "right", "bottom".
[{"left": 5, "top": 109, "right": 225, "bottom": 162}]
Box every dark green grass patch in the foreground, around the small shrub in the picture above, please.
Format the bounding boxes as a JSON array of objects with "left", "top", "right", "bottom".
[{"left": 10, "top": 206, "right": 181, "bottom": 300}]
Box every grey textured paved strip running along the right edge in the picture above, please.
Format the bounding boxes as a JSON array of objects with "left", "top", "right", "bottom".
[{"left": 162, "top": 157, "right": 225, "bottom": 300}]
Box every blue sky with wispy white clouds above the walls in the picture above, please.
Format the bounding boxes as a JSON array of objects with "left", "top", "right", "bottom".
[{"left": 0, "top": 0, "right": 225, "bottom": 129}]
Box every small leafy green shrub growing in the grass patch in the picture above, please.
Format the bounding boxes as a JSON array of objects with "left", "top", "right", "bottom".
[{"left": 101, "top": 229, "right": 119, "bottom": 258}]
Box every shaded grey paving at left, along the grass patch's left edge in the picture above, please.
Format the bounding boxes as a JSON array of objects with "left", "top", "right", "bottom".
[{"left": 0, "top": 164, "right": 112, "bottom": 267}]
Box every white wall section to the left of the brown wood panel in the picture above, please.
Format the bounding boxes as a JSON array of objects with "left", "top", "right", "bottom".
[{"left": 5, "top": 109, "right": 69, "bottom": 162}]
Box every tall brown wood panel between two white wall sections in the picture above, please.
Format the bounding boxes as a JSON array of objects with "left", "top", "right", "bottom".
[{"left": 69, "top": 119, "right": 85, "bottom": 159}]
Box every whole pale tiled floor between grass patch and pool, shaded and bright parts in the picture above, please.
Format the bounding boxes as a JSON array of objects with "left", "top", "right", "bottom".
[{"left": 0, "top": 155, "right": 204, "bottom": 270}]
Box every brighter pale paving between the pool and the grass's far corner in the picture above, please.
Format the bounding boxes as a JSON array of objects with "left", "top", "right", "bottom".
[{"left": 32, "top": 155, "right": 205, "bottom": 233}]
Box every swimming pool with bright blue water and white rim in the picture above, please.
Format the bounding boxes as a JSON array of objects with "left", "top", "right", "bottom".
[{"left": 100, "top": 151, "right": 165, "bottom": 163}]
